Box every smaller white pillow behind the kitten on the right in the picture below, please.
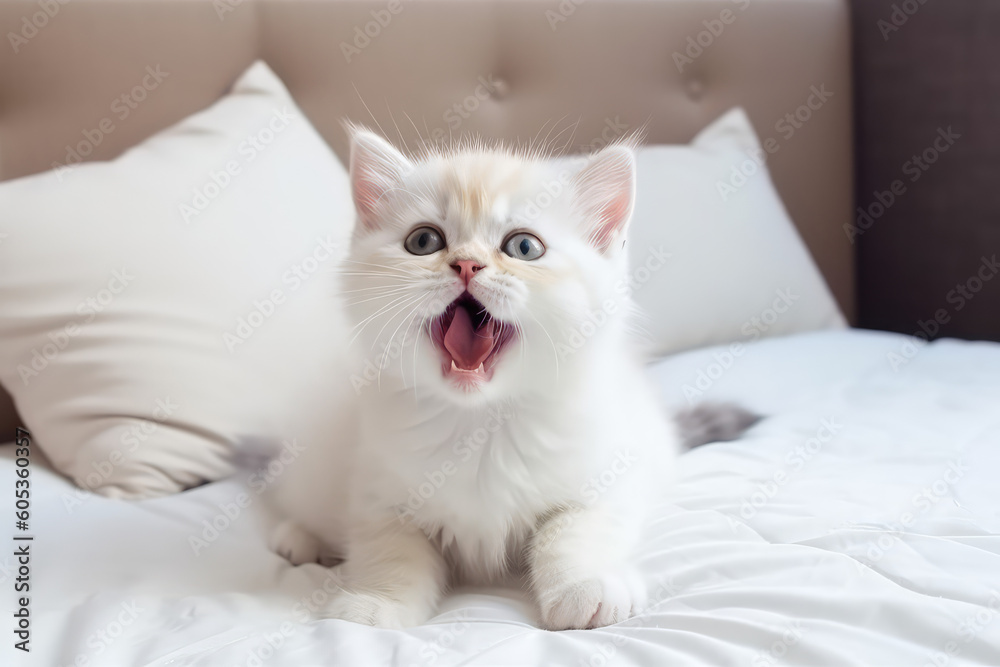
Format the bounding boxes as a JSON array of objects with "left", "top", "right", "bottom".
[{"left": 628, "top": 109, "right": 846, "bottom": 355}]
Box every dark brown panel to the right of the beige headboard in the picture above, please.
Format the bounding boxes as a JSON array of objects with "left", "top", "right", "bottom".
[{"left": 852, "top": 0, "right": 1000, "bottom": 340}]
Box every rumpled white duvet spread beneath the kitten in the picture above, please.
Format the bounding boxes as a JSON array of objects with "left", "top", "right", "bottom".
[{"left": 0, "top": 331, "right": 1000, "bottom": 667}]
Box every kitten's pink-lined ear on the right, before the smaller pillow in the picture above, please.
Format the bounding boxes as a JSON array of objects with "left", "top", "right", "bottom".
[{"left": 575, "top": 144, "right": 635, "bottom": 253}]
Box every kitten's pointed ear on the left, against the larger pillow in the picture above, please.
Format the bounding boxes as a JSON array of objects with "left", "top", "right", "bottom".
[{"left": 349, "top": 127, "right": 413, "bottom": 229}]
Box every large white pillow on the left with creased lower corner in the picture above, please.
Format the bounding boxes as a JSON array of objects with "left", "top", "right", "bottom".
[{"left": 0, "top": 63, "right": 354, "bottom": 497}]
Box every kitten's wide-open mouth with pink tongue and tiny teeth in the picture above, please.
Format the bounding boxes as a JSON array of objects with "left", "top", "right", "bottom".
[{"left": 431, "top": 292, "right": 514, "bottom": 386}]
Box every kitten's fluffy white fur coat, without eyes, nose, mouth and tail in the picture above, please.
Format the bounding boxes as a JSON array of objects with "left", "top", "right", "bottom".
[{"left": 274, "top": 129, "right": 679, "bottom": 630}]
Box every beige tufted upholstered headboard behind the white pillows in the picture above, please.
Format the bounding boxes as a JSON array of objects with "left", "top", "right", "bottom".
[{"left": 0, "top": 0, "right": 854, "bottom": 434}]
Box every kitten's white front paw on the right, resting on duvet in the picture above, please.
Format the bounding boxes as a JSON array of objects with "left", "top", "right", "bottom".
[{"left": 539, "top": 568, "right": 646, "bottom": 630}]
